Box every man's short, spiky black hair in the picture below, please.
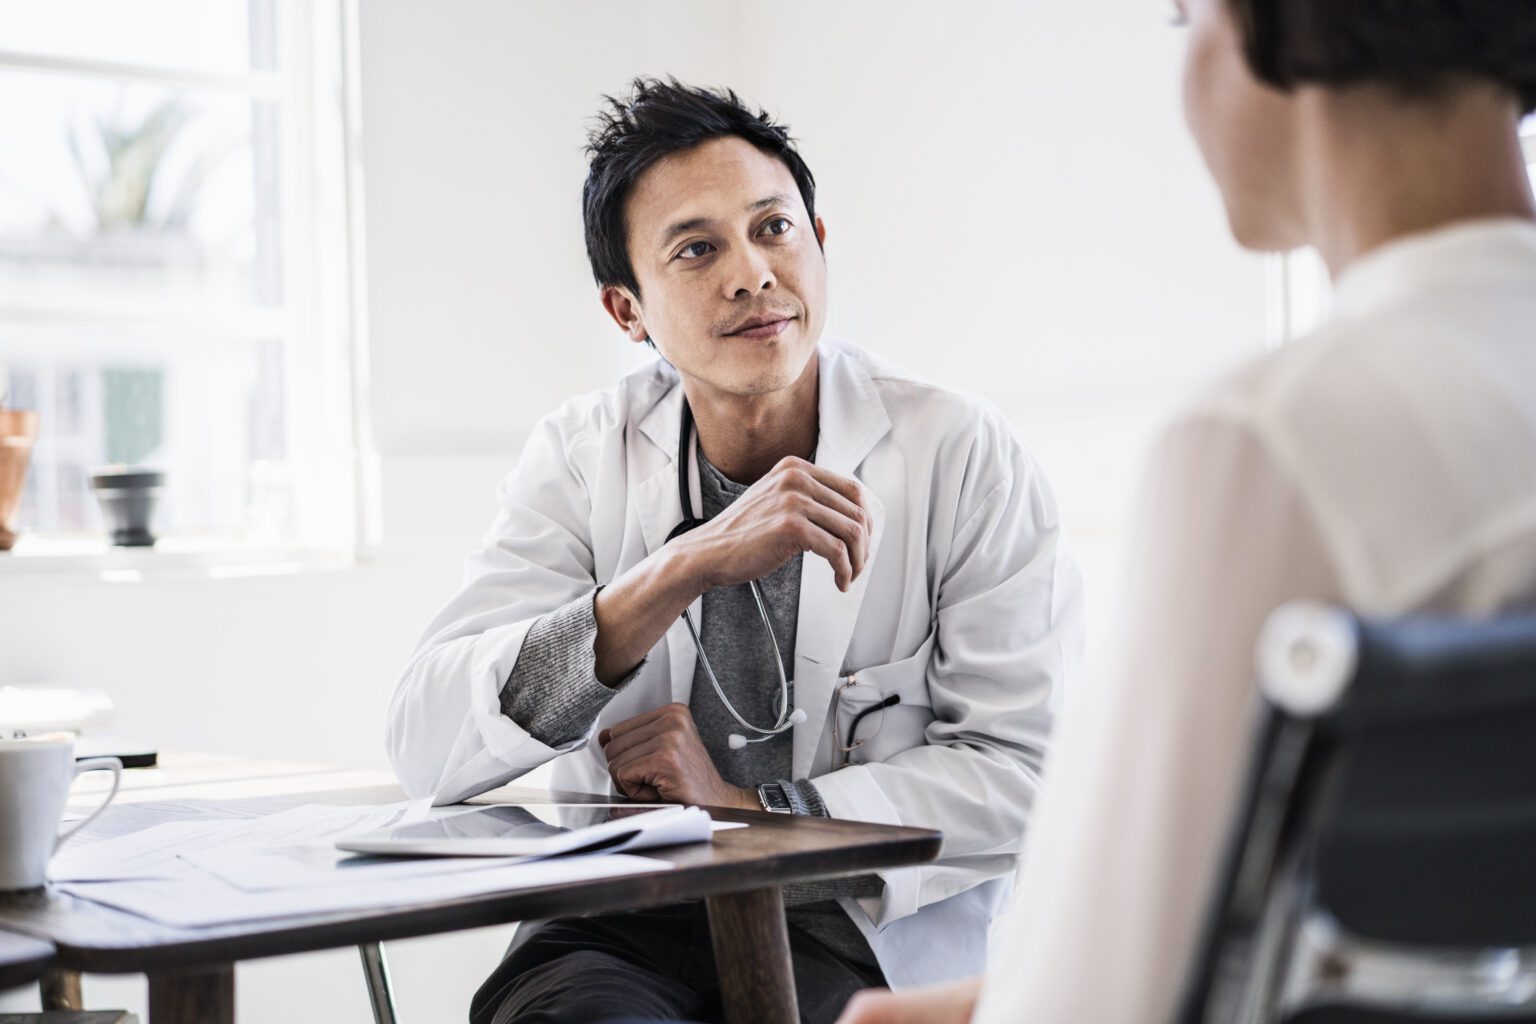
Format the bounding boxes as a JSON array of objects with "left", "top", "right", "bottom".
[{"left": 582, "top": 78, "right": 816, "bottom": 295}]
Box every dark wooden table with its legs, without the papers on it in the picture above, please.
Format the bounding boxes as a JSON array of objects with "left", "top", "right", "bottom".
[{"left": 0, "top": 752, "right": 940, "bottom": 1024}]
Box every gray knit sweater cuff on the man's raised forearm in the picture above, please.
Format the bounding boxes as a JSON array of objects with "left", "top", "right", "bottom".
[{"left": 501, "top": 586, "right": 645, "bottom": 746}]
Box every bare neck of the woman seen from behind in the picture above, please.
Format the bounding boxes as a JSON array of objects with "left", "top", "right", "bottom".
[{"left": 1299, "top": 83, "right": 1536, "bottom": 278}]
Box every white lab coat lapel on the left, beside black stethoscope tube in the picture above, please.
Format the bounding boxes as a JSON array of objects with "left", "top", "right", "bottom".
[{"left": 631, "top": 374, "right": 703, "bottom": 705}]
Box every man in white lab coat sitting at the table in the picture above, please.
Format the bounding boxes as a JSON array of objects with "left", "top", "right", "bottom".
[{"left": 387, "top": 80, "right": 1081, "bottom": 1022}]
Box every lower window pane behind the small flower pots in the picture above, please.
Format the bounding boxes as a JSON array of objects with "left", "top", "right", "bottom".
[{"left": 0, "top": 329, "right": 292, "bottom": 537}]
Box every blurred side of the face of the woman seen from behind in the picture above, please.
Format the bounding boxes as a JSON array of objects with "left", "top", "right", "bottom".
[{"left": 1175, "top": 0, "right": 1306, "bottom": 250}]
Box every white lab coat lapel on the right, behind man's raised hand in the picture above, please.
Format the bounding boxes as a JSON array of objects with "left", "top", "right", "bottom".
[{"left": 794, "top": 345, "right": 891, "bottom": 778}]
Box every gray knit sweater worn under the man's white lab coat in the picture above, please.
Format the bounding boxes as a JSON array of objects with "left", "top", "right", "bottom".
[{"left": 501, "top": 448, "right": 883, "bottom": 966}]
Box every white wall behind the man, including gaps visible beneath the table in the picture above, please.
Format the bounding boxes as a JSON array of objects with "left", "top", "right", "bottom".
[{"left": 0, "top": 0, "right": 1264, "bottom": 1024}]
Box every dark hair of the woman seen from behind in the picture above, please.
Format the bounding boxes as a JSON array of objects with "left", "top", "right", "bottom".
[{"left": 1227, "top": 0, "right": 1536, "bottom": 114}]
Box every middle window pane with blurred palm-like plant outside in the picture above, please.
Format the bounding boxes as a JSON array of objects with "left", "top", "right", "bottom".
[{"left": 0, "top": 71, "right": 283, "bottom": 309}]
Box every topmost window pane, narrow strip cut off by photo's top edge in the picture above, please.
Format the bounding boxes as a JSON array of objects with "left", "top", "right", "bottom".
[{"left": 0, "top": 0, "right": 276, "bottom": 72}]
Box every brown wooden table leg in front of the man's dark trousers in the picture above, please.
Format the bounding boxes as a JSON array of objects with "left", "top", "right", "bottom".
[{"left": 706, "top": 887, "right": 800, "bottom": 1024}]
